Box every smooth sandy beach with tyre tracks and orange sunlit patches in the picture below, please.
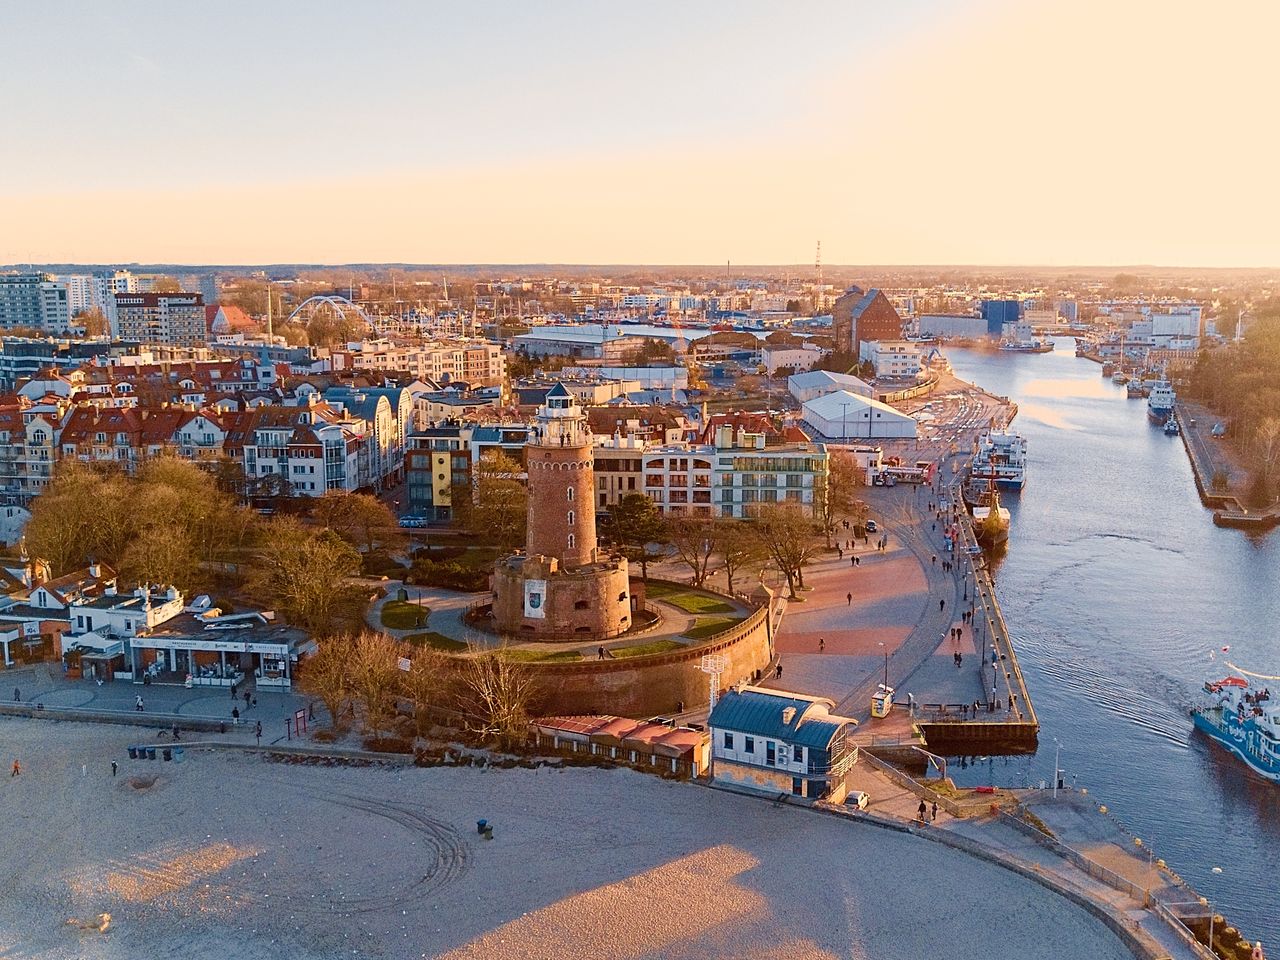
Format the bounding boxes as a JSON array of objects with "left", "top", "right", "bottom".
[{"left": 0, "top": 719, "right": 1129, "bottom": 960}]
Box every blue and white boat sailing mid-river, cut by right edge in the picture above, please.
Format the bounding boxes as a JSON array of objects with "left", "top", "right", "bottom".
[{"left": 1192, "top": 663, "right": 1280, "bottom": 783}]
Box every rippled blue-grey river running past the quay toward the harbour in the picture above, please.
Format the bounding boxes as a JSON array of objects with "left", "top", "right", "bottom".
[{"left": 947, "top": 338, "right": 1280, "bottom": 954}]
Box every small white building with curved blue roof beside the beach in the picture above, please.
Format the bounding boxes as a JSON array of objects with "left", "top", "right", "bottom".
[{"left": 708, "top": 686, "right": 858, "bottom": 804}]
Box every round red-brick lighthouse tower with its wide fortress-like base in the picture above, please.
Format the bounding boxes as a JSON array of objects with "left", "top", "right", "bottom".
[{"left": 493, "top": 383, "right": 631, "bottom": 640}]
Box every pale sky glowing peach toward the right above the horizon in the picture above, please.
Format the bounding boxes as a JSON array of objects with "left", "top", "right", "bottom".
[{"left": 0, "top": 0, "right": 1280, "bottom": 266}]
